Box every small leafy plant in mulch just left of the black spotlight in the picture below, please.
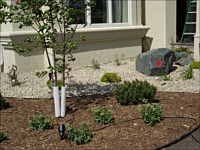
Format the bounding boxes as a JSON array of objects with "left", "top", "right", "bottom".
[{"left": 29, "top": 113, "right": 51, "bottom": 130}]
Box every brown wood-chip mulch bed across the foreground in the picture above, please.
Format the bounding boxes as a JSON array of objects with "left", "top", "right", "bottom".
[{"left": 0, "top": 92, "right": 200, "bottom": 150}]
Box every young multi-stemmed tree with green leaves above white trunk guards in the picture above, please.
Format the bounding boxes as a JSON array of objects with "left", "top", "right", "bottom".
[{"left": 4, "top": 0, "right": 90, "bottom": 117}]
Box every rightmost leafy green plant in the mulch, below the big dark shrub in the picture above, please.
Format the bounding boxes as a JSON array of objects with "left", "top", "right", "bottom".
[{"left": 138, "top": 104, "right": 163, "bottom": 126}]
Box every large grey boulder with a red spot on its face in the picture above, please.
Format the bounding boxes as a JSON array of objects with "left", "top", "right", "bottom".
[{"left": 136, "top": 48, "right": 175, "bottom": 76}]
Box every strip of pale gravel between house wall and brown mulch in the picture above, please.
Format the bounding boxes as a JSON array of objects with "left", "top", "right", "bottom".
[{"left": 1, "top": 59, "right": 200, "bottom": 98}]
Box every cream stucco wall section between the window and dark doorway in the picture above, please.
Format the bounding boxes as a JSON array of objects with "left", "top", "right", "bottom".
[{"left": 145, "top": 0, "right": 176, "bottom": 49}]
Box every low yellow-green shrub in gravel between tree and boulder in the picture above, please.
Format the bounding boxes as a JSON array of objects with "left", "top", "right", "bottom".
[{"left": 100, "top": 73, "right": 122, "bottom": 83}]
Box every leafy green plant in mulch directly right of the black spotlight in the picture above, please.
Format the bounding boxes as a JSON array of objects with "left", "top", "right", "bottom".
[{"left": 66, "top": 124, "right": 93, "bottom": 144}]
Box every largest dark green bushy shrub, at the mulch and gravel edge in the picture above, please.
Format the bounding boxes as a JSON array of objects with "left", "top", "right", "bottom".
[{"left": 114, "top": 80, "right": 157, "bottom": 105}]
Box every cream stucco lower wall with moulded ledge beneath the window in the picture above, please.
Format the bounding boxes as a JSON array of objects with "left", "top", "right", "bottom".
[{"left": 0, "top": 26, "right": 149, "bottom": 72}]
